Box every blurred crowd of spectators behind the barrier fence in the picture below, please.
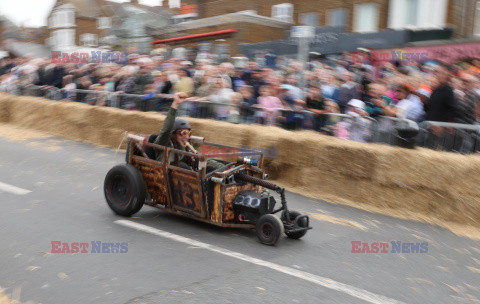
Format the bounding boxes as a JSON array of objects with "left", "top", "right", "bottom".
[{"left": 0, "top": 52, "right": 480, "bottom": 141}]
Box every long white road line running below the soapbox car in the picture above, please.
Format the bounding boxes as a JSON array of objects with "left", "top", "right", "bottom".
[{"left": 115, "top": 220, "right": 405, "bottom": 304}]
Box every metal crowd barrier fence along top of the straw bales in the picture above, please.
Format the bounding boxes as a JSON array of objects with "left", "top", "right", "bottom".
[{"left": 4, "top": 85, "right": 480, "bottom": 154}]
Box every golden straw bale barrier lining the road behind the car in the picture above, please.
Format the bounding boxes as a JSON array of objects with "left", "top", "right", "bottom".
[{"left": 0, "top": 94, "right": 480, "bottom": 236}]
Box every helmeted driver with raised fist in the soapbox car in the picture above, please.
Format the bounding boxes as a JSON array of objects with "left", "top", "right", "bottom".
[{"left": 153, "top": 92, "right": 224, "bottom": 172}]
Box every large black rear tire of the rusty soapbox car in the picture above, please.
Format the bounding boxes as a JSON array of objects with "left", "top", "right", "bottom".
[{"left": 103, "top": 164, "right": 147, "bottom": 216}]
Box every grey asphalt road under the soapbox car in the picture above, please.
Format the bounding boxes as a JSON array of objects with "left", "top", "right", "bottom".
[{"left": 0, "top": 126, "right": 480, "bottom": 304}]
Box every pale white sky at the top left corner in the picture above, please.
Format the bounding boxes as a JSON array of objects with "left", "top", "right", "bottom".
[{"left": 0, "top": 0, "right": 162, "bottom": 27}]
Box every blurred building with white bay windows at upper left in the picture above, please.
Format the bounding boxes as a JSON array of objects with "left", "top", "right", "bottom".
[{"left": 45, "top": 0, "right": 171, "bottom": 53}]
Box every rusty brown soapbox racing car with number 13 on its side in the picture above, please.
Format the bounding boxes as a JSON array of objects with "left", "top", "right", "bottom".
[{"left": 104, "top": 134, "right": 311, "bottom": 245}]
